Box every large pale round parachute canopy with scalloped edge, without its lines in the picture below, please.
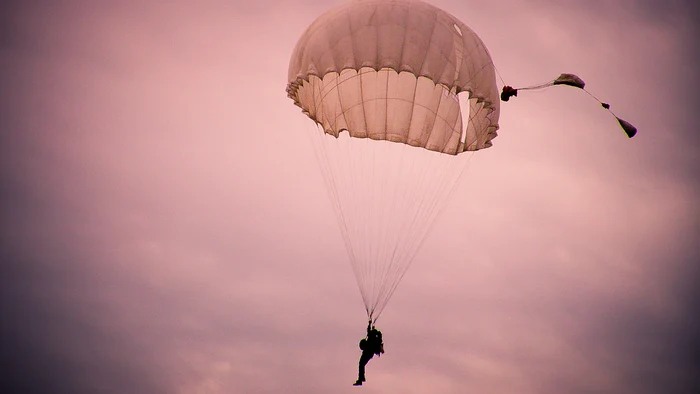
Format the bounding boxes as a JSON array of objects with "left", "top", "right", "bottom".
[{"left": 287, "top": 0, "right": 500, "bottom": 154}]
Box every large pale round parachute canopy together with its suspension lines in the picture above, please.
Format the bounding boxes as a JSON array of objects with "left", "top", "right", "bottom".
[{"left": 287, "top": 0, "right": 500, "bottom": 320}]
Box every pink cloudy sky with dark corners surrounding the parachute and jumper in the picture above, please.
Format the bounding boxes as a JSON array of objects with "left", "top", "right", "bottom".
[{"left": 0, "top": 0, "right": 700, "bottom": 394}]
